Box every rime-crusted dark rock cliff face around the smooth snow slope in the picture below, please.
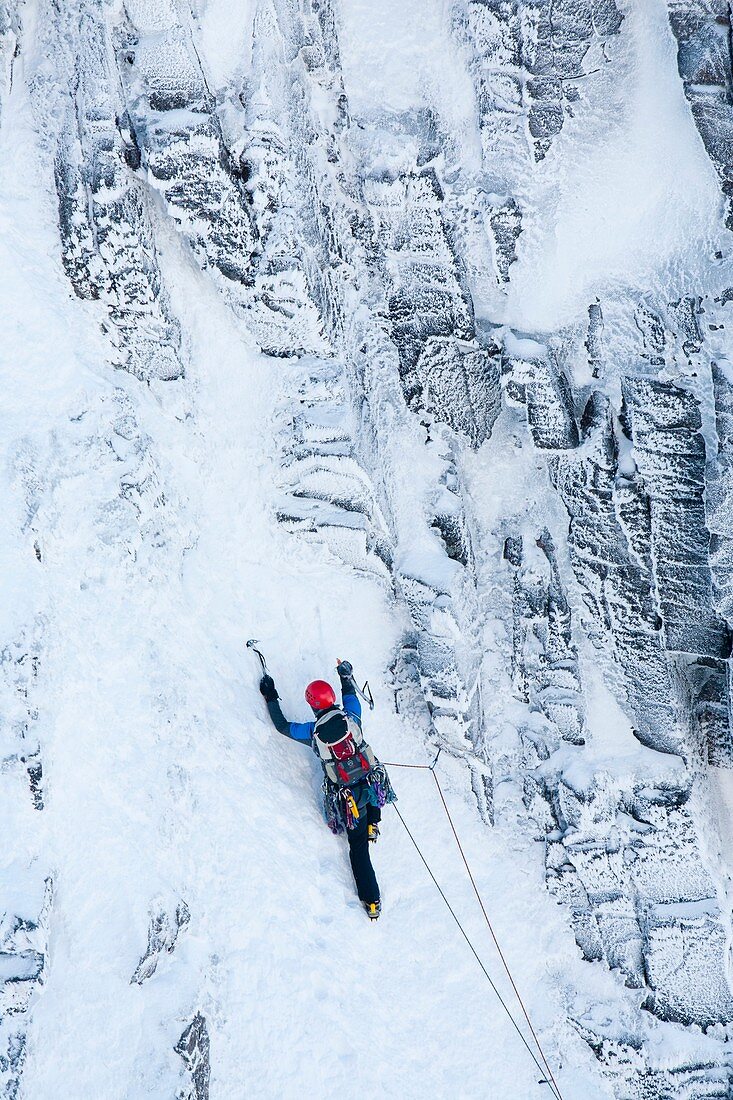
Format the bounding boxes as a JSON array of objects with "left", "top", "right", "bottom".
[{"left": 0, "top": 0, "right": 733, "bottom": 1100}]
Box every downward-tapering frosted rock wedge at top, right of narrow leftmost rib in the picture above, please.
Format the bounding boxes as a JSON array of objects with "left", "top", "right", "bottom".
[{"left": 118, "top": 3, "right": 327, "bottom": 355}]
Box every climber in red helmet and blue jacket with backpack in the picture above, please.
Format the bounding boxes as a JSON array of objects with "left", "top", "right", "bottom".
[{"left": 260, "top": 661, "right": 395, "bottom": 921}]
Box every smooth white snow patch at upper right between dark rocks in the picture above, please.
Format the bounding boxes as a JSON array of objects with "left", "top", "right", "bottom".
[{"left": 506, "top": 0, "right": 722, "bottom": 331}]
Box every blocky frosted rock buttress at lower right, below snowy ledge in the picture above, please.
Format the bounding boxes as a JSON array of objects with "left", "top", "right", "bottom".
[{"left": 537, "top": 758, "right": 733, "bottom": 1026}]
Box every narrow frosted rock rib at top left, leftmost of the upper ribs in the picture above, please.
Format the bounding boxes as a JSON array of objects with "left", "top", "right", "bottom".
[{"left": 35, "top": 6, "right": 183, "bottom": 380}]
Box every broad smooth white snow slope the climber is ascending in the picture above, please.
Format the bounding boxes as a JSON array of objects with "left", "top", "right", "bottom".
[{"left": 2, "top": 12, "right": 583, "bottom": 1100}]
